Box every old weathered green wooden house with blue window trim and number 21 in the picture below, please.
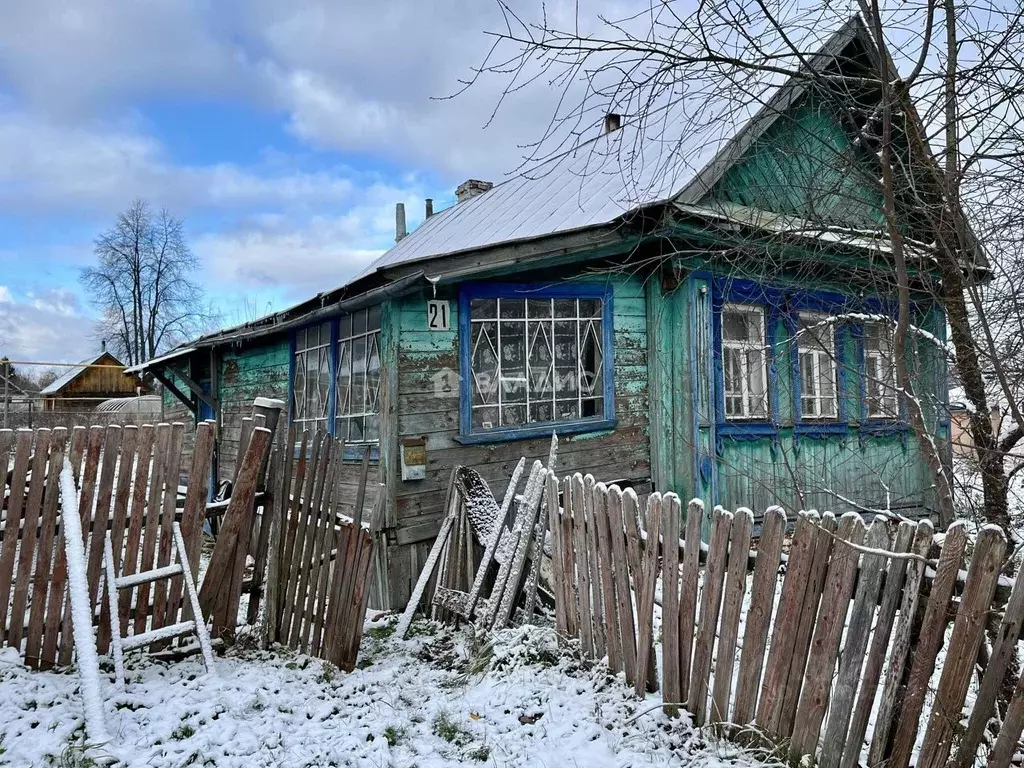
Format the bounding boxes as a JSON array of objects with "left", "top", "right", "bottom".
[{"left": 128, "top": 18, "right": 966, "bottom": 605}]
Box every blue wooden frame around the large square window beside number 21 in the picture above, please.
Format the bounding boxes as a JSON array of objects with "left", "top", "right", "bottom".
[{"left": 456, "top": 283, "right": 615, "bottom": 444}]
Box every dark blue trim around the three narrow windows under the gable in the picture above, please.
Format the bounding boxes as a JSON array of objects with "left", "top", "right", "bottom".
[{"left": 712, "top": 271, "right": 907, "bottom": 440}]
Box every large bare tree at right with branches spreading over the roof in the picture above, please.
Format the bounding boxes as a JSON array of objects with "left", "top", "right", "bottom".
[{"left": 466, "top": 0, "right": 1024, "bottom": 538}]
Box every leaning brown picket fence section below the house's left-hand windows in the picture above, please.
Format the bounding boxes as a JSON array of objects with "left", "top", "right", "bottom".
[{"left": 264, "top": 427, "right": 381, "bottom": 670}]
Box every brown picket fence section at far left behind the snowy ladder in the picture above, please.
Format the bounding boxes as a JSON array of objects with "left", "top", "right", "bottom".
[{"left": 0, "top": 424, "right": 213, "bottom": 669}]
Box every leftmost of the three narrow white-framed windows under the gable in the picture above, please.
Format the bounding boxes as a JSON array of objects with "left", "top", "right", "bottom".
[{"left": 722, "top": 304, "right": 768, "bottom": 419}]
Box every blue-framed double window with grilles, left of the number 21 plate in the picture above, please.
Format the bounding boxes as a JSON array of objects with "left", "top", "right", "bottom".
[{"left": 292, "top": 306, "right": 381, "bottom": 443}]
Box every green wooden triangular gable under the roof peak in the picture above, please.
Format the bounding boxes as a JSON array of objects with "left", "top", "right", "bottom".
[{"left": 702, "top": 97, "right": 885, "bottom": 229}]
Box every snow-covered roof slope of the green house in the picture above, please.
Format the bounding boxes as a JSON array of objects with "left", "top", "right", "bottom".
[{"left": 354, "top": 16, "right": 863, "bottom": 280}]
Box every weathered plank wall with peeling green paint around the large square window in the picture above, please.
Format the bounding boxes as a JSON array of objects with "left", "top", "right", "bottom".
[{"left": 391, "top": 272, "right": 651, "bottom": 597}]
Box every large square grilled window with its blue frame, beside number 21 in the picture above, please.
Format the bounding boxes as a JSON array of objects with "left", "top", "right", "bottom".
[{"left": 460, "top": 284, "right": 613, "bottom": 439}]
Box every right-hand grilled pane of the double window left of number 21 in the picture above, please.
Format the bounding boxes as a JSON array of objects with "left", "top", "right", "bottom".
[{"left": 334, "top": 306, "right": 381, "bottom": 442}]
